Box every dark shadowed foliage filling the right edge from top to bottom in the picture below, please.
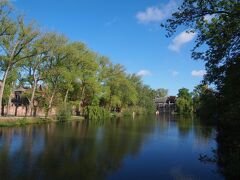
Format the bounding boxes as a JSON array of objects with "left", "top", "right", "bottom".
[{"left": 162, "top": 0, "right": 240, "bottom": 179}]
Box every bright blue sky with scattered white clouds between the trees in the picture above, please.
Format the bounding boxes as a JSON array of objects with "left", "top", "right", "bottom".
[{"left": 13, "top": 0, "right": 205, "bottom": 95}]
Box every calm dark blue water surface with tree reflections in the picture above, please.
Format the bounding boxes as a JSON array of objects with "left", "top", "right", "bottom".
[{"left": 0, "top": 115, "right": 223, "bottom": 180}]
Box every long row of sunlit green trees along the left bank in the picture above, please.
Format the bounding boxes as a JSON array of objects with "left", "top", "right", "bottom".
[{"left": 0, "top": 1, "right": 155, "bottom": 120}]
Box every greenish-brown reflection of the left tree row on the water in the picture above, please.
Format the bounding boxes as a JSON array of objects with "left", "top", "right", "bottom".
[{"left": 0, "top": 118, "right": 154, "bottom": 179}]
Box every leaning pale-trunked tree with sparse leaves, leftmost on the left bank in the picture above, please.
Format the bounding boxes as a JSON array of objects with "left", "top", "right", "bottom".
[{"left": 0, "top": 18, "right": 39, "bottom": 116}]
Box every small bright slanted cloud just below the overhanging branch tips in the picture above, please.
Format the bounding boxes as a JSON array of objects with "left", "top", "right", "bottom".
[{"left": 168, "top": 31, "right": 196, "bottom": 52}]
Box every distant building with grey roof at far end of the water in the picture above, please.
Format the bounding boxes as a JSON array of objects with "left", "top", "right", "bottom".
[{"left": 154, "top": 96, "right": 177, "bottom": 112}]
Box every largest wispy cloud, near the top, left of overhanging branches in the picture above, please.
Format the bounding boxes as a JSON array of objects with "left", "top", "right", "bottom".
[{"left": 136, "top": 0, "right": 177, "bottom": 24}]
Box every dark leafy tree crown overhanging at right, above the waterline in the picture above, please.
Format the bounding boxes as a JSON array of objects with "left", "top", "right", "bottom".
[{"left": 162, "top": 0, "right": 240, "bottom": 118}]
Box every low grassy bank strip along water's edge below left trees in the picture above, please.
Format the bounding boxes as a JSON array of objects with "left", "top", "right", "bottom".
[{"left": 0, "top": 117, "right": 83, "bottom": 127}]
